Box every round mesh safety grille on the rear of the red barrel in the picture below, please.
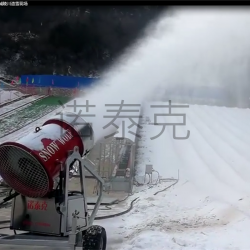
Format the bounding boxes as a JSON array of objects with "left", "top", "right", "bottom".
[{"left": 0, "top": 145, "right": 49, "bottom": 198}]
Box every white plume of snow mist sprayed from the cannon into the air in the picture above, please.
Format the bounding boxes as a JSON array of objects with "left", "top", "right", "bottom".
[{"left": 67, "top": 7, "right": 250, "bottom": 141}]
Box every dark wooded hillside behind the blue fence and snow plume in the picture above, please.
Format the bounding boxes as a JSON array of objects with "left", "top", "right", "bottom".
[{"left": 0, "top": 6, "right": 165, "bottom": 76}]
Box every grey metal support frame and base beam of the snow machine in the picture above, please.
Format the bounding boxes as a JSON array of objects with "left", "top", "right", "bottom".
[{"left": 0, "top": 147, "right": 104, "bottom": 250}]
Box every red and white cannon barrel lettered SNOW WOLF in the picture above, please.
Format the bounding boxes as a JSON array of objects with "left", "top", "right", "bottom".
[{"left": 0, "top": 112, "right": 94, "bottom": 198}]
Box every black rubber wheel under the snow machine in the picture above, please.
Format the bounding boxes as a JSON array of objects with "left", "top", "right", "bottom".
[{"left": 82, "top": 226, "right": 107, "bottom": 250}]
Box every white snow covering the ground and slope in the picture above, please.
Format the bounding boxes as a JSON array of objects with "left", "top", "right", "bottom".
[{"left": 0, "top": 103, "right": 250, "bottom": 250}]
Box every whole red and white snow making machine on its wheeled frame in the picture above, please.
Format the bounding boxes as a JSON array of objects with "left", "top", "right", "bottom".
[{"left": 0, "top": 112, "right": 107, "bottom": 250}]
